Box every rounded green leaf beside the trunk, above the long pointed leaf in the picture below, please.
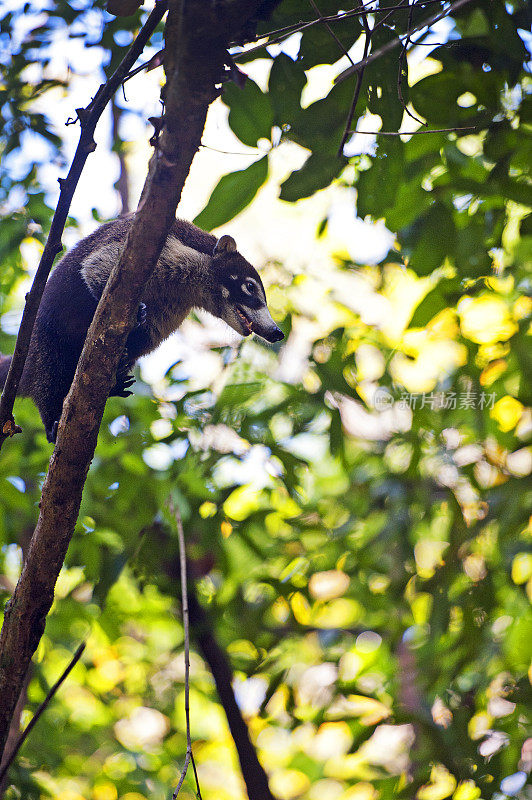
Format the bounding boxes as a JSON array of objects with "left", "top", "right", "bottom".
[{"left": 223, "top": 78, "right": 273, "bottom": 147}]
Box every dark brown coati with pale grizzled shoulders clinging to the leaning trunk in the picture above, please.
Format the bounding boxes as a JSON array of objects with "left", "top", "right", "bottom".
[{"left": 0, "top": 214, "right": 284, "bottom": 442}]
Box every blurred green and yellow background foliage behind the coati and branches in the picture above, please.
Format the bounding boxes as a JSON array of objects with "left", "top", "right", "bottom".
[{"left": 0, "top": 0, "right": 532, "bottom": 800}]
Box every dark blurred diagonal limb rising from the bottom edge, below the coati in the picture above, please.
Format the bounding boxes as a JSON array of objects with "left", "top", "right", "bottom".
[{"left": 188, "top": 586, "right": 275, "bottom": 800}]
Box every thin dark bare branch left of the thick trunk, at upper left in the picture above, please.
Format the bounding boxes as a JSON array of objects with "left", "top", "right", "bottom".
[{"left": 0, "top": 0, "right": 167, "bottom": 448}]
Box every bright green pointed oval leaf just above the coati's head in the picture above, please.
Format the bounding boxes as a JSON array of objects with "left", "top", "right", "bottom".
[{"left": 194, "top": 156, "right": 268, "bottom": 230}]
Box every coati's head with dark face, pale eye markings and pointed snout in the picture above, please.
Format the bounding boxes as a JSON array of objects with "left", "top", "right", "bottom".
[{"left": 213, "top": 236, "right": 284, "bottom": 342}]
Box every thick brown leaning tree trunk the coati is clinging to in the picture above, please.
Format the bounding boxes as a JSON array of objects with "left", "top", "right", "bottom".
[{"left": 0, "top": 0, "right": 274, "bottom": 752}]
